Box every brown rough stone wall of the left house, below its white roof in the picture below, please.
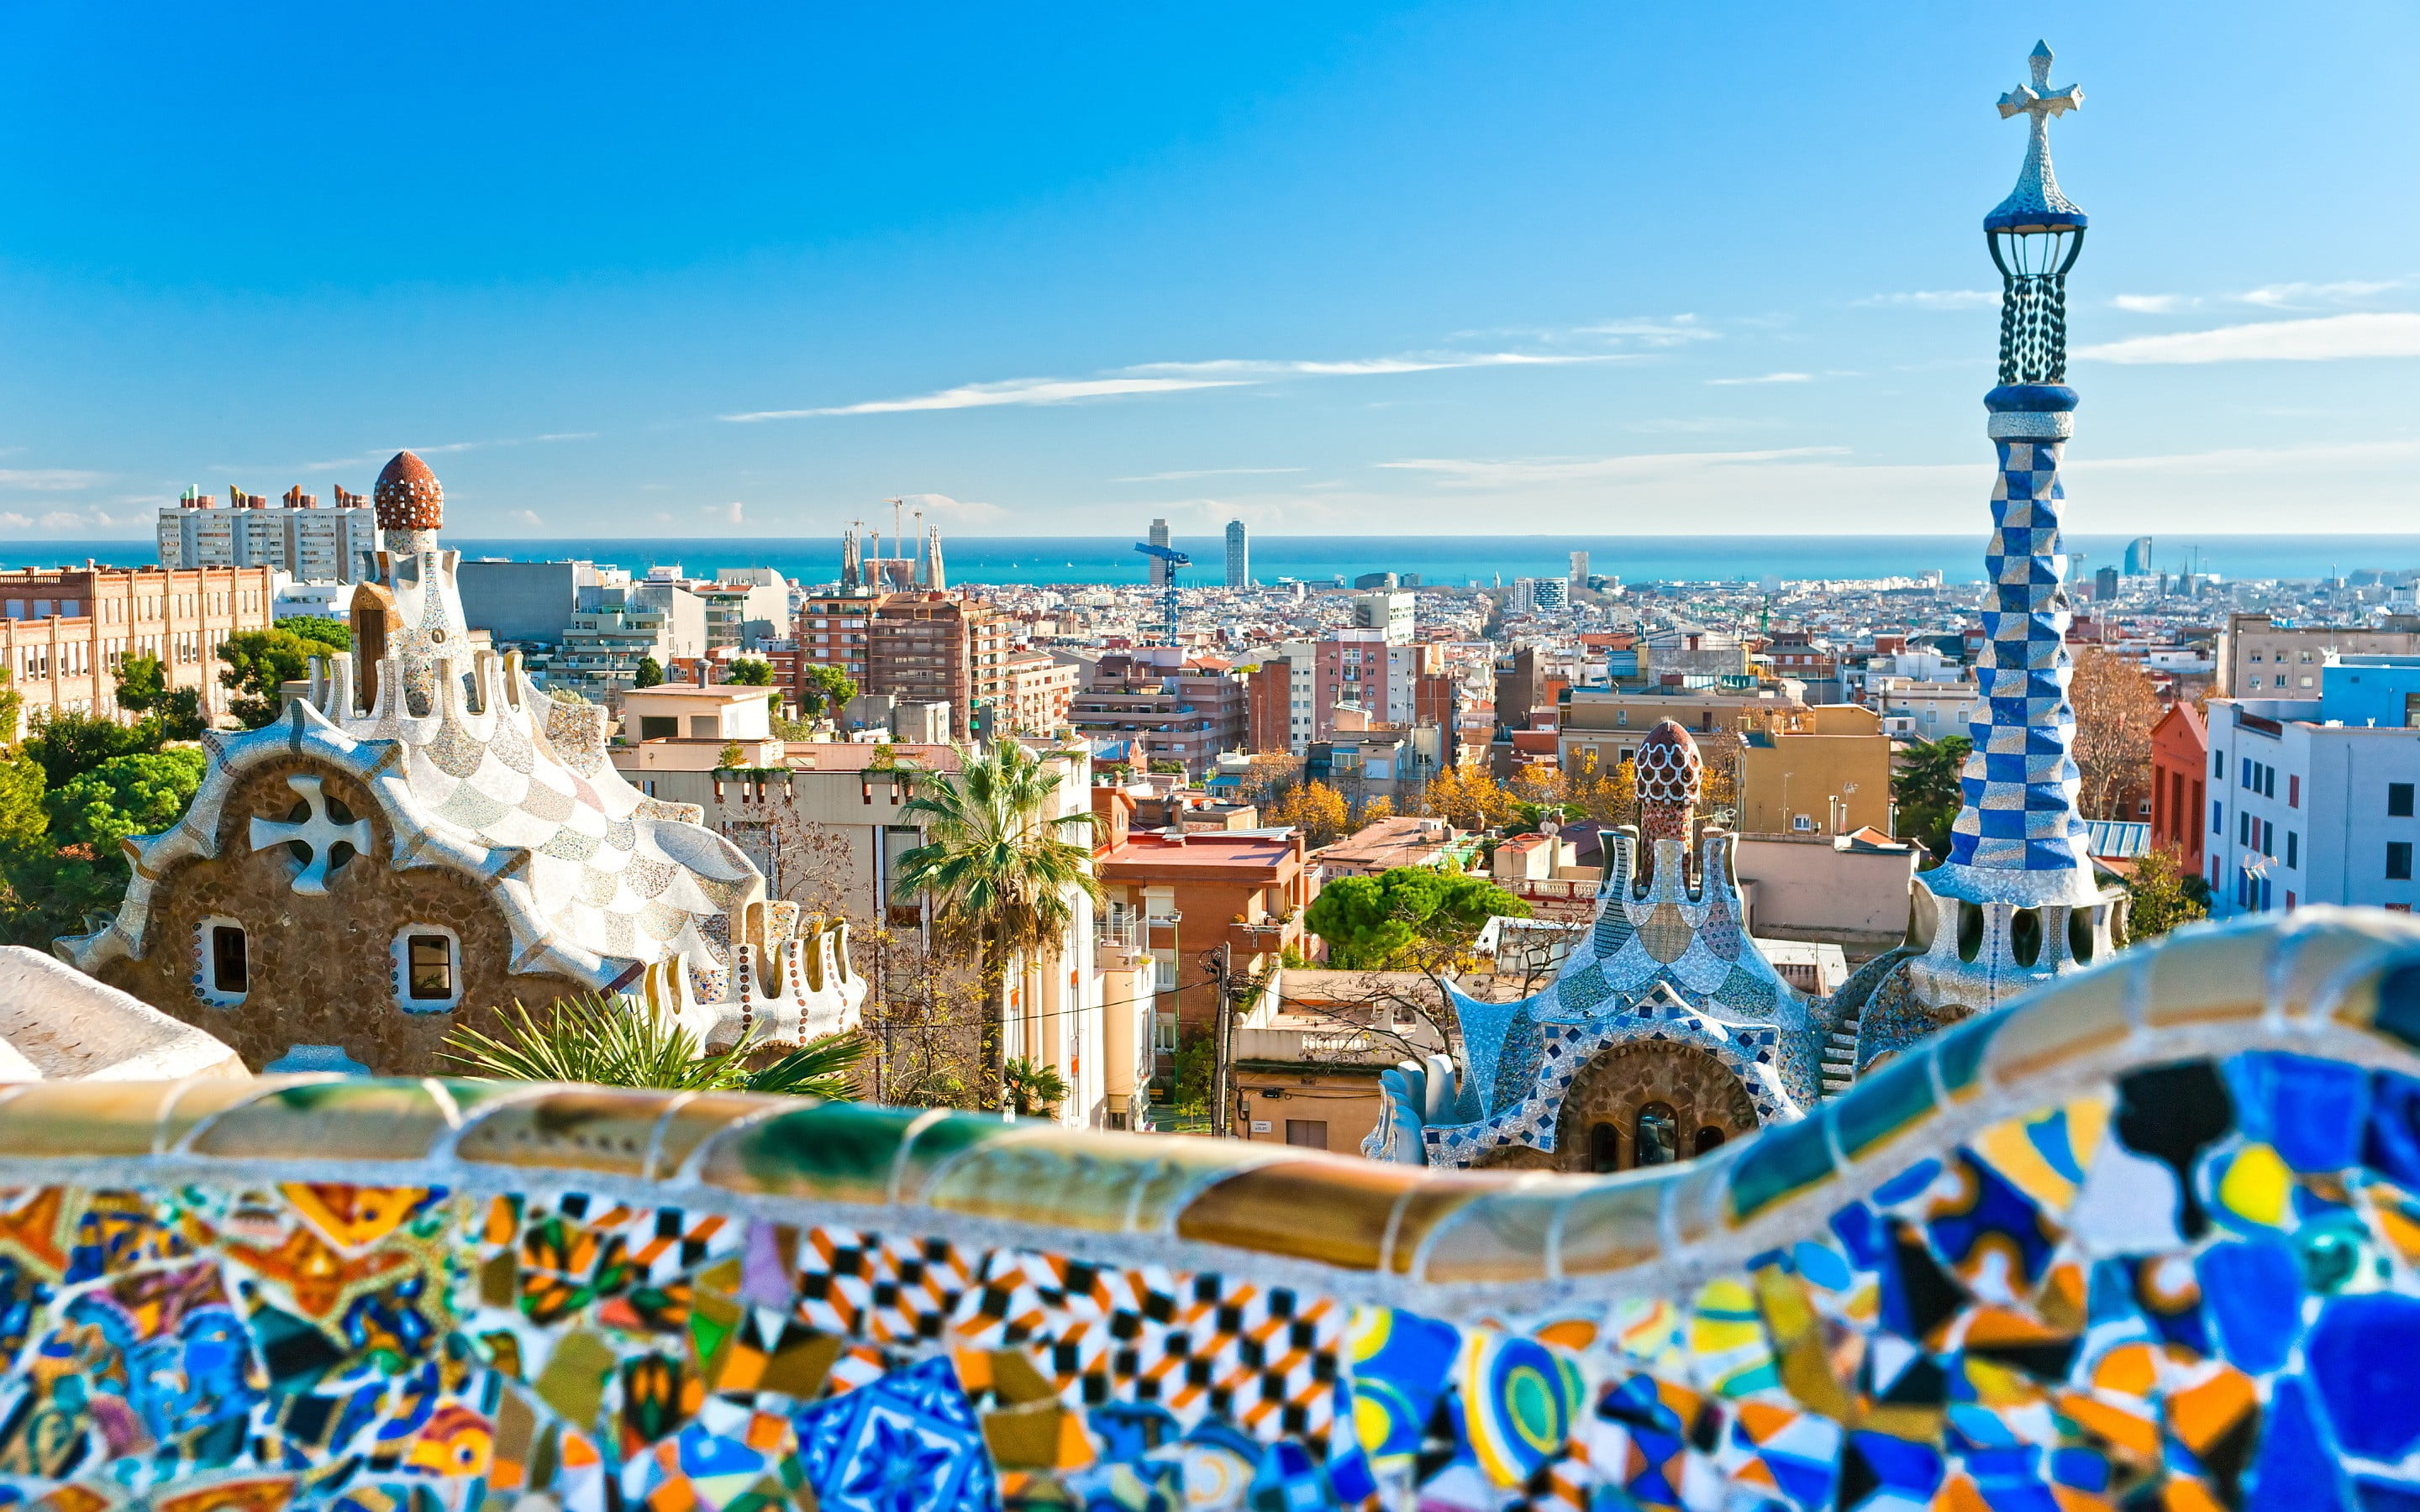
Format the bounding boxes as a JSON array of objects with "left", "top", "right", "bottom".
[{"left": 99, "top": 757, "right": 583, "bottom": 1077}]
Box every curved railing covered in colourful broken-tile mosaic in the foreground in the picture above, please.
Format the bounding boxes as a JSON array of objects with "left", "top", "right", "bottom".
[{"left": 0, "top": 910, "right": 2420, "bottom": 1512}]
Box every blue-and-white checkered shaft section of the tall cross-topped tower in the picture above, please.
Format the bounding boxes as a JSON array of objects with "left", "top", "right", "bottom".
[{"left": 1950, "top": 430, "right": 2088, "bottom": 871}]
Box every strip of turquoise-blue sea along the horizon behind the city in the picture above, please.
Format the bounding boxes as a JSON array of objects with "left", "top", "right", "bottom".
[{"left": 0, "top": 533, "right": 2420, "bottom": 585}]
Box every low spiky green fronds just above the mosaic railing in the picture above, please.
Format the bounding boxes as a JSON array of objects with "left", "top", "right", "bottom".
[{"left": 440, "top": 995, "right": 874, "bottom": 1100}]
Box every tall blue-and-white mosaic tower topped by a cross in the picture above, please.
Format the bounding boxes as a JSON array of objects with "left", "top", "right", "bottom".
[{"left": 1861, "top": 46, "right": 2125, "bottom": 1035}]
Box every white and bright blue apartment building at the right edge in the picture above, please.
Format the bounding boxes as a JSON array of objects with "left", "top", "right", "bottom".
[{"left": 2202, "top": 655, "right": 2420, "bottom": 919}]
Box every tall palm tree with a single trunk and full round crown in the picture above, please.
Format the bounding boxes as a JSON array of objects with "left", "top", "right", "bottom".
[{"left": 893, "top": 740, "right": 1103, "bottom": 1099}]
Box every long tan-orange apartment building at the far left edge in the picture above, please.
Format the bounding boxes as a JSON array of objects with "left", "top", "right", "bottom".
[{"left": 0, "top": 566, "right": 276, "bottom": 740}]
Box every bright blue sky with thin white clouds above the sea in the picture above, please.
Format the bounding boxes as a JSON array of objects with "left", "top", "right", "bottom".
[{"left": 0, "top": 0, "right": 2420, "bottom": 539}]
